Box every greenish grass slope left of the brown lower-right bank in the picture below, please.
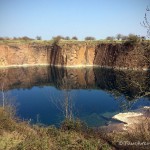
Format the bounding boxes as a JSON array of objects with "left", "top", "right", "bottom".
[{"left": 0, "top": 107, "right": 112, "bottom": 150}]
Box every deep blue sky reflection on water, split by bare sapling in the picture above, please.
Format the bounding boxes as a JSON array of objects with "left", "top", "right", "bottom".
[{"left": 11, "top": 86, "right": 150, "bottom": 126}]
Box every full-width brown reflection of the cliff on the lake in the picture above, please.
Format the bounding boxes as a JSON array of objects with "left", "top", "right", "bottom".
[{"left": 0, "top": 67, "right": 150, "bottom": 99}]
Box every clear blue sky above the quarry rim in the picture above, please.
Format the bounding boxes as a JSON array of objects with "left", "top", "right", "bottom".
[{"left": 0, "top": 0, "right": 150, "bottom": 40}]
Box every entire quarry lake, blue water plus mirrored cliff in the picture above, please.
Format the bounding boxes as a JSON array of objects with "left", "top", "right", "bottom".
[{"left": 0, "top": 66, "right": 150, "bottom": 127}]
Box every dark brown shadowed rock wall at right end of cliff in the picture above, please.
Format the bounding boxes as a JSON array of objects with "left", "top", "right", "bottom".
[{"left": 94, "top": 44, "right": 149, "bottom": 70}]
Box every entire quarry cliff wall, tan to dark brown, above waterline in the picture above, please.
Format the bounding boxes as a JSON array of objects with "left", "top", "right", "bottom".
[{"left": 0, "top": 42, "right": 150, "bottom": 70}]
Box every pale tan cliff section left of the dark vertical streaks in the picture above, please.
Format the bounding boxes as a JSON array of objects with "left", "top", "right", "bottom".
[{"left": 0, "top": 44, "right": 50, "bottom": 67}]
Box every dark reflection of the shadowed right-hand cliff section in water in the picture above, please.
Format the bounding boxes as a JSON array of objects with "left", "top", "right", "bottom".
[{"left": 94, "top": 69, "right": 150, "bottom": 101}]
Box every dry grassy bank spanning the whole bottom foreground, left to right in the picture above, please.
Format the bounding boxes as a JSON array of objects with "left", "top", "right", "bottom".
[{"left": 0, "top": 107, "right": 150, "bottom": 150}]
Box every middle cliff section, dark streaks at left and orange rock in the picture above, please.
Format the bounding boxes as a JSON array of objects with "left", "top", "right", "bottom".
[{"left": 50, "top": 43, "right": 95, "bottom": 66}]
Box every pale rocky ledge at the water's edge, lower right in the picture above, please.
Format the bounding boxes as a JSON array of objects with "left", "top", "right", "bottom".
[{"left": 102, "top": 106, "right": 150, "bottom": 132}]
